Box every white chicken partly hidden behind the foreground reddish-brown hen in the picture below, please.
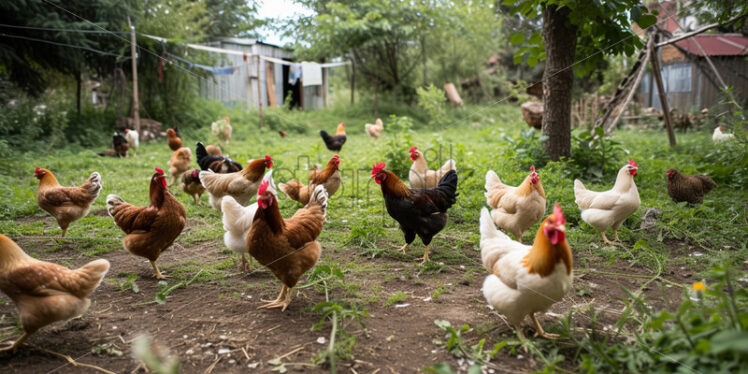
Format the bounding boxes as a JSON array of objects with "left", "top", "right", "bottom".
[{"left": 221, "top": 170, "right": 278, "bottom": 271}]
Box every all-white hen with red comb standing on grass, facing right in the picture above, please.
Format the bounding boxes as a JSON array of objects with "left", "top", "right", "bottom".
[{"left": 574, "top": 160, "right": 641, "bottom": 245}]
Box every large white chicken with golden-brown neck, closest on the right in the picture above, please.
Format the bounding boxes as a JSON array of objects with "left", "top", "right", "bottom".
[{"left": 480, "top": 204, "right": 574, "bottom": 340}]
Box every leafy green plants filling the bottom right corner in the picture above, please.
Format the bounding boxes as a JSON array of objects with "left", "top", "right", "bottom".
[{"left": 563, "top": 267, "right": 748, "bottom": 373}]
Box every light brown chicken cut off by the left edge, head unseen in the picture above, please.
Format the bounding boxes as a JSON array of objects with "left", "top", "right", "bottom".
[{"left": 0, "top": 234, "right": 109, "bottom": 352}]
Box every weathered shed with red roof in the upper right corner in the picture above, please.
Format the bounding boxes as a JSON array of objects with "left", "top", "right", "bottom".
[{"left": 634, "top": 2, "right": 748, "bottom": 113}]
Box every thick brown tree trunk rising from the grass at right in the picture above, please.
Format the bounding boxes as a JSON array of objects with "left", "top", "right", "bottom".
[{"left": 543, "top": 5, "right": 577, "bottom": 161}]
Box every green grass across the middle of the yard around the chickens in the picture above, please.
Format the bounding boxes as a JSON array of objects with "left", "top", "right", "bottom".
[{"left": 0, "top": 101, "right": 748, "bottom": 368}]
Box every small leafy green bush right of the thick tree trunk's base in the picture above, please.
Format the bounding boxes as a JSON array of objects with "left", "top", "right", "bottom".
[{"left": 569, "top": 127, "right": 627, "bottom": 180}]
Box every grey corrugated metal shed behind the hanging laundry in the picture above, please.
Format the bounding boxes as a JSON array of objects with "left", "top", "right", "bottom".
[{"left": 200, "top": 38, "right": 328, "bottom": 109}]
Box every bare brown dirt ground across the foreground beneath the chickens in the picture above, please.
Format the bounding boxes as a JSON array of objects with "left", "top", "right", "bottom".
[{"left": 0, "top": 213, "right": 690, "bottom": 373}]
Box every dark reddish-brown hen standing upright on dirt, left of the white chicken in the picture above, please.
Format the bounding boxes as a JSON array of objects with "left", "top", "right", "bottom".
[{"left": 106, "top": 168, "right": 187, "bottom": 279}]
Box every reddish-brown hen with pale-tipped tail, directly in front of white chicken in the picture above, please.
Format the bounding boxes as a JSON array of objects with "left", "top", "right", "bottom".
[{"left": 247, "top": 181, "right": 327, "bottom": 311}]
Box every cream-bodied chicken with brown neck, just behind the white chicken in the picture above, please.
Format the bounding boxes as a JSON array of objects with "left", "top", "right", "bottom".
[{"left": 200, "top": 155, "right": 273, "bottom": 211}]
